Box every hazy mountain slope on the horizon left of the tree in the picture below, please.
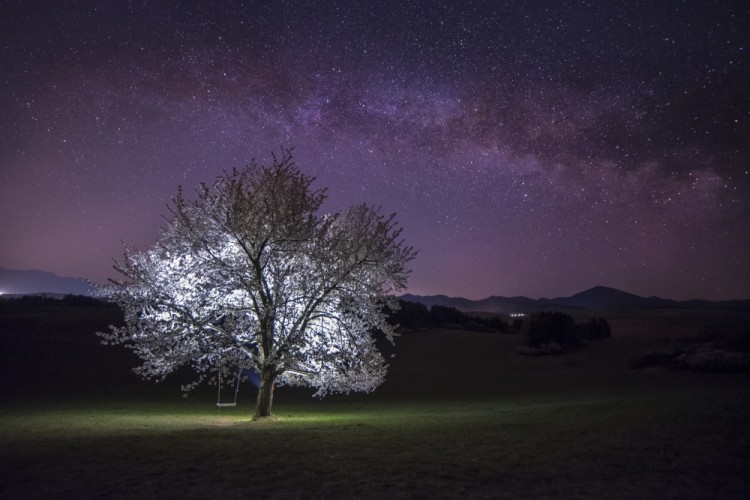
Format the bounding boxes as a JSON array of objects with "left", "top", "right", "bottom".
[{"left": 0, "top": 267, "right": 91, "bottom": 295}]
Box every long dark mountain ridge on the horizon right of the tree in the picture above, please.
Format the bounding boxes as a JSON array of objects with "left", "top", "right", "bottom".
[{"left": 401, "top": 286, "right": 750, "bottom": 314}]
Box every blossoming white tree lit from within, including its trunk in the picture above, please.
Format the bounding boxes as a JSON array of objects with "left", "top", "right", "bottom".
[{"left": 100, "top": 150, "right": 415, "bottom": 418}]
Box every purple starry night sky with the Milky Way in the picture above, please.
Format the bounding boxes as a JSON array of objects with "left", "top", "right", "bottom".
[{"left": 0, "top": 0, "right": 750, "bottom": 299}]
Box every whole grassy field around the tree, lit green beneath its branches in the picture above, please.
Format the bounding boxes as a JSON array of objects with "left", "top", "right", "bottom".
[{"left": 0, "top": 302, "right": 750, "bottom": 498}]
